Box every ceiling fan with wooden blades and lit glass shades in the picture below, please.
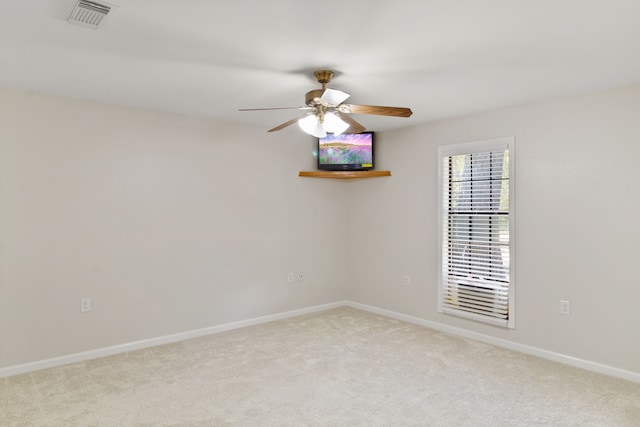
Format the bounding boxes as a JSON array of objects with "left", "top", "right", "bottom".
[{"left": 240, "top": 70, "right": 412, "bottom": 138}]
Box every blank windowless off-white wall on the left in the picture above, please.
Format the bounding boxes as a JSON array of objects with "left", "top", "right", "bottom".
[{"left": 0, "top": 90, "right": 348, "bottom": 368}]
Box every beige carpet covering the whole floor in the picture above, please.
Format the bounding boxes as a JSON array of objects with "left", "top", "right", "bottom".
[{"left": 0, "top": 308, "right": 640, "bottom": 427}]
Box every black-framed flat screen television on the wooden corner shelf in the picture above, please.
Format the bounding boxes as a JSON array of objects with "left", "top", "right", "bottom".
[{"left": 318, "top": 132, "right": 374, "bottom": 171}]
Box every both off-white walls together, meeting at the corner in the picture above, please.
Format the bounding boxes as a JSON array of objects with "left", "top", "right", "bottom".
[{"left": 0, "top": 86, "right": 640, "bottom": 378}]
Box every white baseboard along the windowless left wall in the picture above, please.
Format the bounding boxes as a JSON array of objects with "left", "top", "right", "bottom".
[{"left": 0, "top": 302, "right": 346, "bottom": 378}]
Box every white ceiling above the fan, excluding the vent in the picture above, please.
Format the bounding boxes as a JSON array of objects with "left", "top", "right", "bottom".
[{"left": 0, "top": 0, "right": 640, "bottom": 132}]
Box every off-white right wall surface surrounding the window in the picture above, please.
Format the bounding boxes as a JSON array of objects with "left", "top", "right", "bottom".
[{"left": 349, "top": 86, "right": 640, "bottom": 372}]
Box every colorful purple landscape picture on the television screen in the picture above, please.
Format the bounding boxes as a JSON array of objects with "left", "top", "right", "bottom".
[{"left": 318, "top": 133, "right": 373, "bottom": 165}]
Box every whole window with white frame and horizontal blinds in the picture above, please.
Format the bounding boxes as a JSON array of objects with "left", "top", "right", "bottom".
[{"left": 438, "top": 138, "right": 515, "bottom": 328}]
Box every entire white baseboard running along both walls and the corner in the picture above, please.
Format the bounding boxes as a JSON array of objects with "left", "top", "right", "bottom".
[{"left": 0, "top": 301, "right": 640, "bottom": 383}]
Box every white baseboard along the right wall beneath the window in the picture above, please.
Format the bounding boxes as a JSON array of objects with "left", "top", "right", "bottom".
[{"left": 346, "top": 301, "right": 640, "bottom": 383}]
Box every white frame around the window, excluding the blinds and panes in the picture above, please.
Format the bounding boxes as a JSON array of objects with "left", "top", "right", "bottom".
[{"left": 437, "top": 137, "right": 516, "bottom": 329}]
